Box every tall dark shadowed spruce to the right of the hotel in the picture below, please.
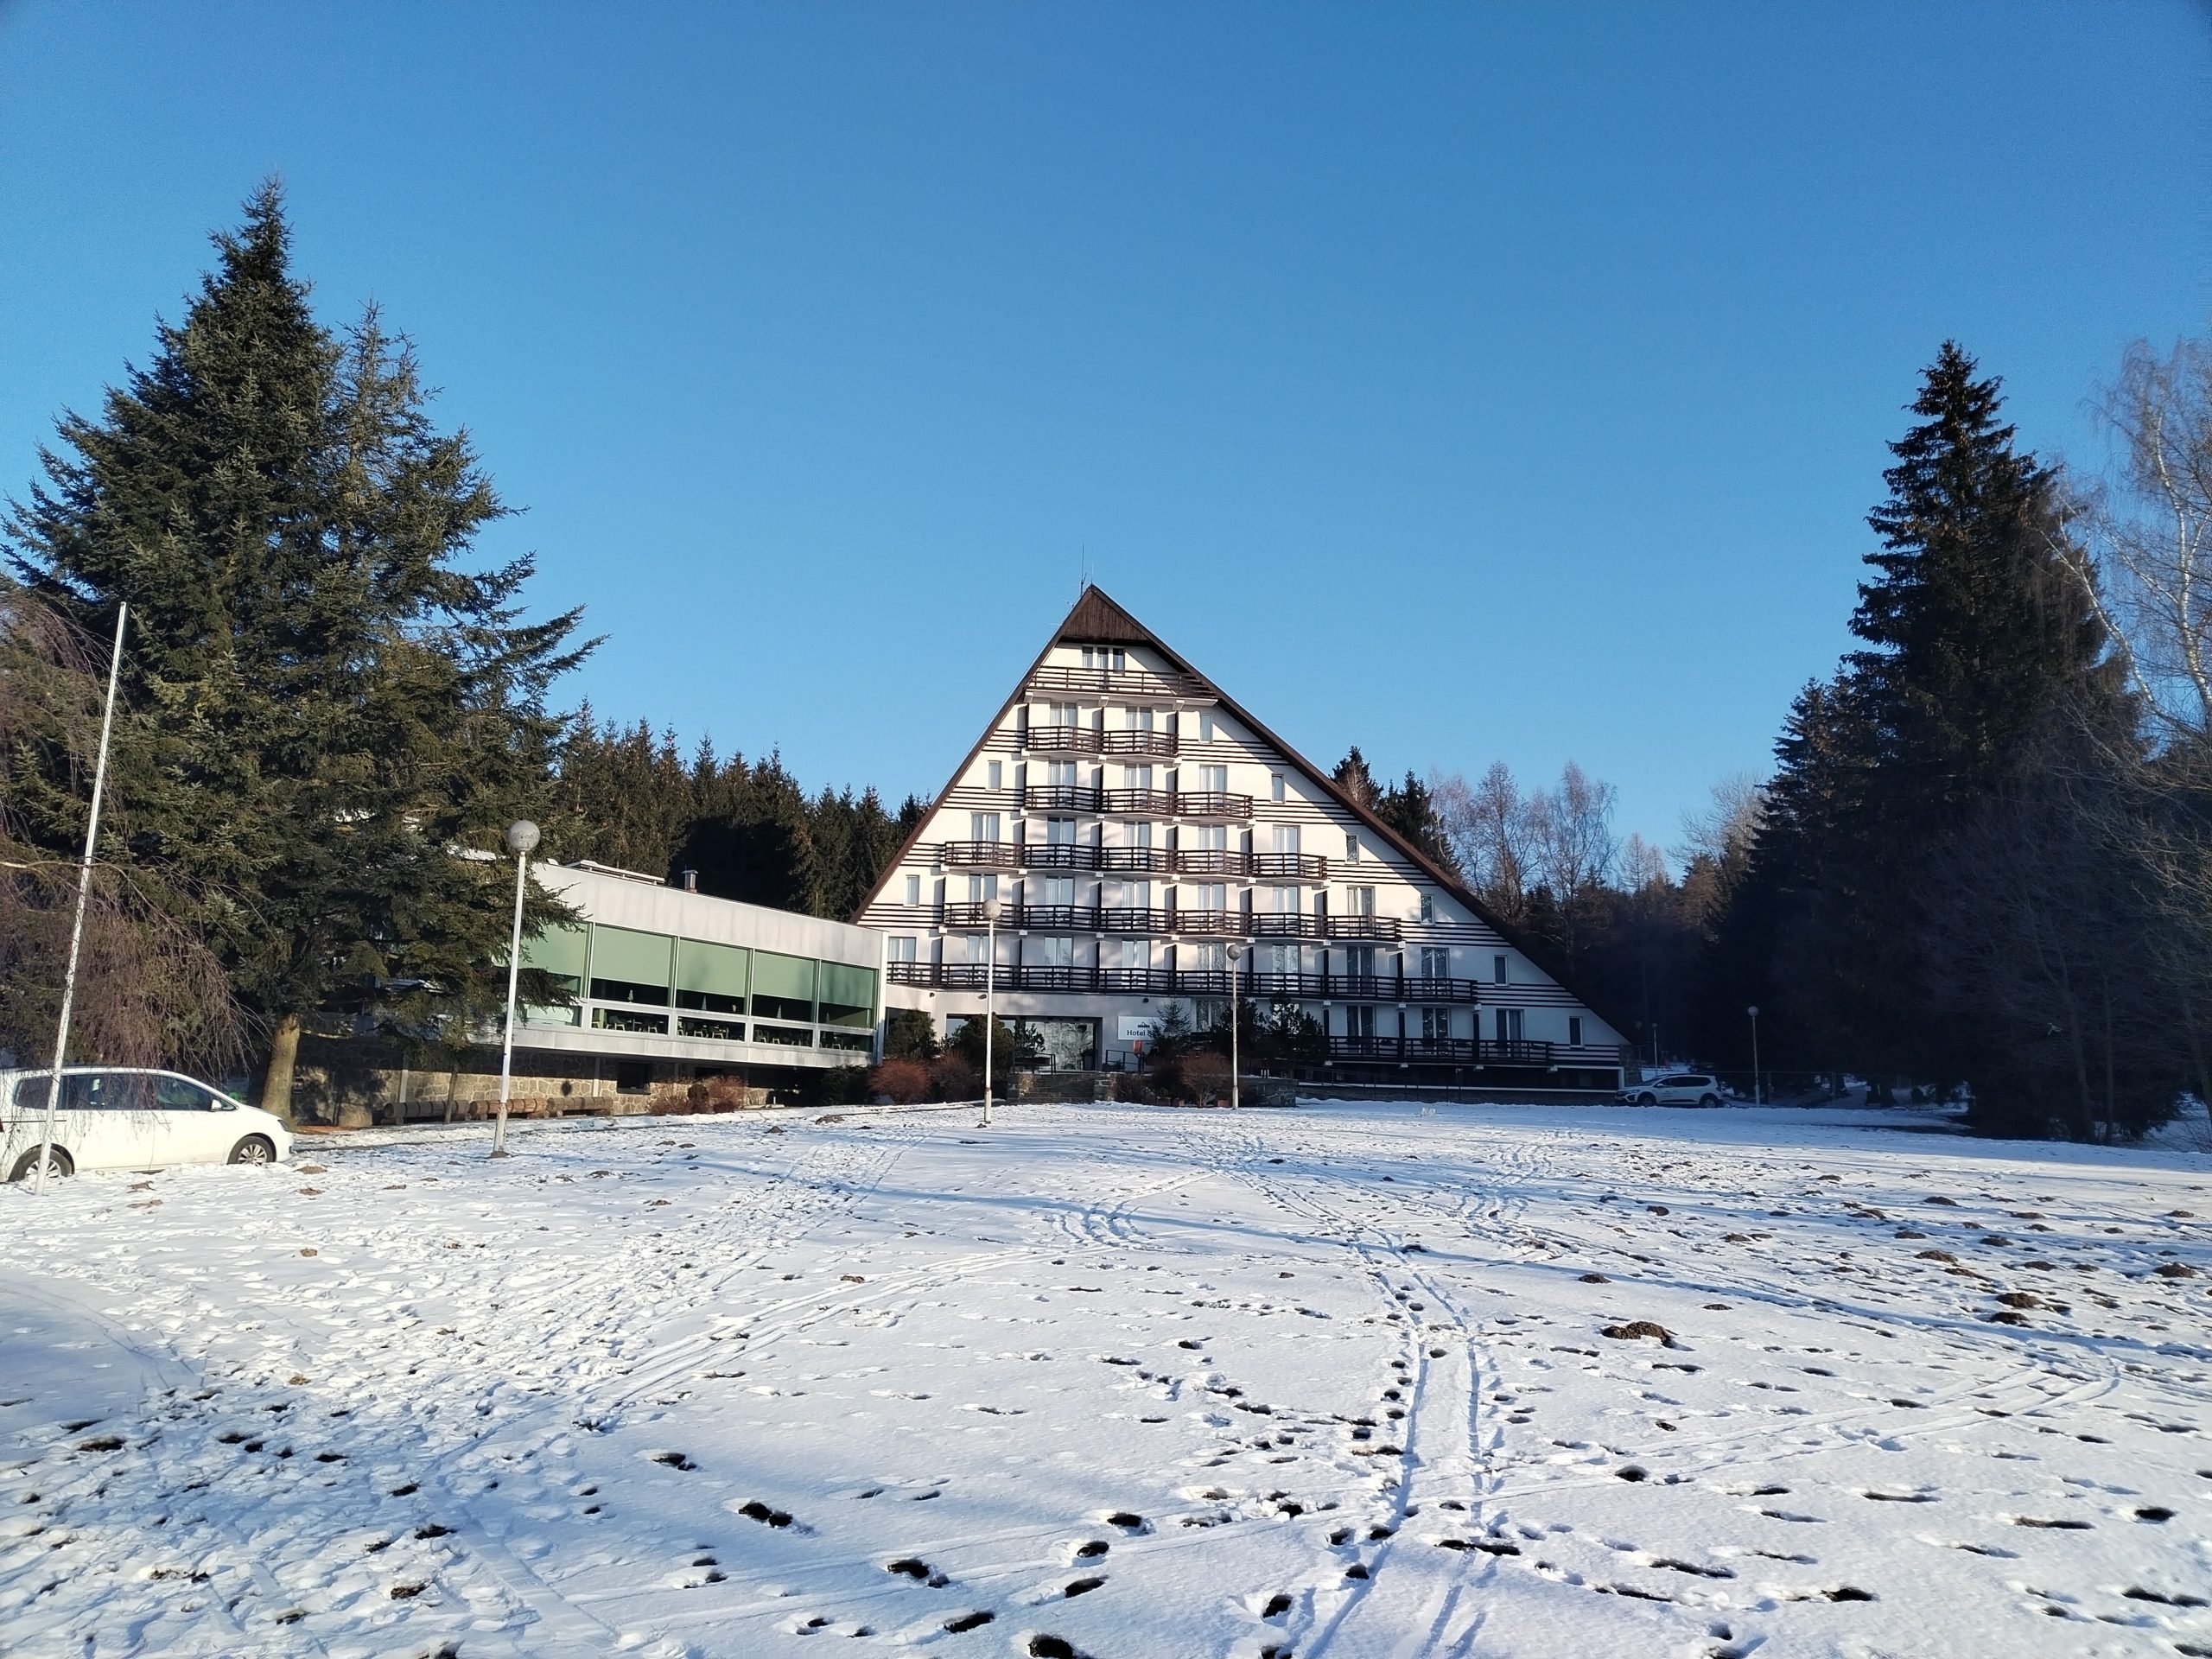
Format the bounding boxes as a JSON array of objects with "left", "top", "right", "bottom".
[{"left": 1707, "top": 343, "right": 2110, "bottom": 1084}]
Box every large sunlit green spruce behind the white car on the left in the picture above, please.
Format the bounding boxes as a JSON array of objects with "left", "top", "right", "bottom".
[{"left": 7, "top": 183, "right": 582, "bottom": 1110}]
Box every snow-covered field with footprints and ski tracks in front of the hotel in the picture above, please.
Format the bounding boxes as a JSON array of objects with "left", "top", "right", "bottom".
[{"left": 0, "top": 1103, "right": 2212, "bottom": 1659}]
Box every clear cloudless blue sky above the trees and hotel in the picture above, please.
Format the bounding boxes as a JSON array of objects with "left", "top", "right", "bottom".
[{"left": 0, "top": 0, "right": 2212, "bottom": 858}]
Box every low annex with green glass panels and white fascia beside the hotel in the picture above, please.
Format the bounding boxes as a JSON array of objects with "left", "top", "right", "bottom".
[{"left": 515, "top": 865, "right": 882, "bottom": 1093}]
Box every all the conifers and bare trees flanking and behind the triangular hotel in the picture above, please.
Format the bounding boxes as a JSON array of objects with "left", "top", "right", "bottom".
[{"left": 0, "top": 186, "right": 2212, "bottom": 1137}]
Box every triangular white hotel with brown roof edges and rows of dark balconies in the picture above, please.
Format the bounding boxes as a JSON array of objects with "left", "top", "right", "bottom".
[{"left": 856, "top": 588, "right": 1626, "bottom": 1090}]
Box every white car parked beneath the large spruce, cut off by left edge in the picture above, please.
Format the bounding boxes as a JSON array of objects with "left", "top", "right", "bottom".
[{"left": 0, "top": 1066, "right": 292, "bottom": 1181}]
